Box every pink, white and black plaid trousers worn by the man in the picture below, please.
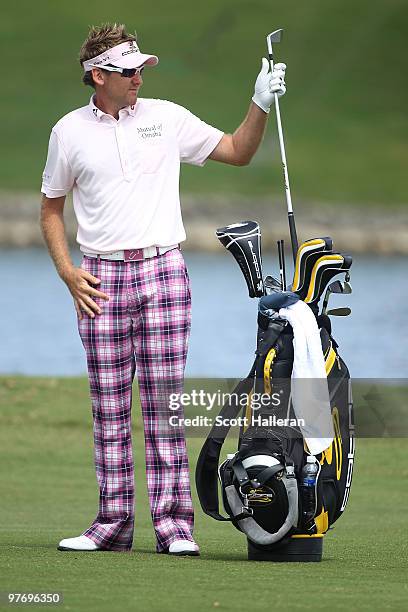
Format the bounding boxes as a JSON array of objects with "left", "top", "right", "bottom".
[{"left": 78, "top": 249, "right": 194, "bottom": 552}]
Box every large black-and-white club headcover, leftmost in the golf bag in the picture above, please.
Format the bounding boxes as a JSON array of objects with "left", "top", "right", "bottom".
[{"left": 215, "top": 221, "right": 265, "bottom": 297}]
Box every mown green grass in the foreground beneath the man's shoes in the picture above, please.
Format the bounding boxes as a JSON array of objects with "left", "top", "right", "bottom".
[{"left": 0, "top": 377, "right": 408, "bottom": 612}]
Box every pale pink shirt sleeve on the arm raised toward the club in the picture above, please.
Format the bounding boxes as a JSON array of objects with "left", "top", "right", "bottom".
[{"left": 174, "top": 104, "right": 224, "bottom": 166}]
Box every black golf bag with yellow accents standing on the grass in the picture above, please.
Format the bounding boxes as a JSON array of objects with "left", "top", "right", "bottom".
[{"left": 196, "top": 228, "right": 354, "bottom": 561}]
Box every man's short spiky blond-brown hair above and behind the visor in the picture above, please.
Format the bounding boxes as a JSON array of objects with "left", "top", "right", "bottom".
[{"left": 79, "top": 23, "right": 137, "bottom": 87}]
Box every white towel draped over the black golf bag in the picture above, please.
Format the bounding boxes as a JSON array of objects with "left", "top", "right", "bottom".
[{"left": 279, "top": 300, "right": 334, "bottom": 455}]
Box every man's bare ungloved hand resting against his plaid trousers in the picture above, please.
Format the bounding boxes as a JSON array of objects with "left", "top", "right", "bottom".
[{"left": 63, "top": 268, "right": 109, "bottom": 319}]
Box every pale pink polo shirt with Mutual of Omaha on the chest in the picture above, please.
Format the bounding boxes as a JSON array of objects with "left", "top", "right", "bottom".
[{"left": 41, "top": 98, "right": 223, "bottom": 253}]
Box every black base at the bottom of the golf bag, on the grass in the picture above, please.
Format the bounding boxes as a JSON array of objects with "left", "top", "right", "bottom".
[{"left": 248, "top": 534, "right": 323, "bottom": 563}]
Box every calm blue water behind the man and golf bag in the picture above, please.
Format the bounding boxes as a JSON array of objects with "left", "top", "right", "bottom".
[{"left": 0, "top": 249, "right": 408, "bottom": 378}]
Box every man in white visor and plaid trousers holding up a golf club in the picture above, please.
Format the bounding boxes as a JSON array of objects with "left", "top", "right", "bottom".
[{"left": 41, "top": 24, "right": 286, "bottom": 555}]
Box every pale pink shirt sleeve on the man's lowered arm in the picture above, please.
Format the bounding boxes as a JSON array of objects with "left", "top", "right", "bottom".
[{"left": 41, "top": 128, "right": 75, "bottom": 198}]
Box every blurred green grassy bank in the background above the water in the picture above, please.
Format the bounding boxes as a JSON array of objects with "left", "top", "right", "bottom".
[{"left": 0, "top": 0, "right": 408, "bottom": 205}]
